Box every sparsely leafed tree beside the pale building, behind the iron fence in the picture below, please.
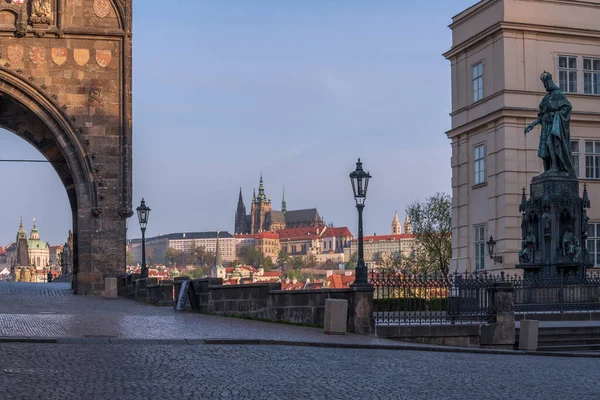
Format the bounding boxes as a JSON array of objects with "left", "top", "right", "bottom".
[{"left": 406, "top": 193, "right": 452, "bottom": 275}]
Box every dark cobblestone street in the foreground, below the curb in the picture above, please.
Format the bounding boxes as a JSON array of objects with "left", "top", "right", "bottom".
[{"left": 0, "top": 344, "right": 600, "bottom": 400}]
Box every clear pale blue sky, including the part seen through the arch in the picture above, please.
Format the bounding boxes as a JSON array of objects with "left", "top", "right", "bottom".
[{"left": 0, "top": 0, "right": 477, "bottom": 245}]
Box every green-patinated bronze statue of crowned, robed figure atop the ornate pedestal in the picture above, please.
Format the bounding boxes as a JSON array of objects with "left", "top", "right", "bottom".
[{"left": 525, "top": 72, "right": 575, "bottom": 175}]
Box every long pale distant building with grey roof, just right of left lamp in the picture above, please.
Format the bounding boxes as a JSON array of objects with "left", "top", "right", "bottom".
[{"left": 128, "top": 231, "right": 236, "bottom": 264}]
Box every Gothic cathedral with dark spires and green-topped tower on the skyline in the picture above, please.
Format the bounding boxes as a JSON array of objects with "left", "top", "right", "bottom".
[{"left": 235, "top": 175, "right": 324, "bottom": 234}]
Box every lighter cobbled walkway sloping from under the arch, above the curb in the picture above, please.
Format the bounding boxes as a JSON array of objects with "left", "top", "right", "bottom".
[{"left": 0, "top": 282, "right": 406, "bottom": 345}]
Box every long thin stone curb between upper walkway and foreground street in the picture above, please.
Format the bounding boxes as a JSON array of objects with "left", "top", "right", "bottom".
[{"left": 0, "top": 337, "right": 600, "bottom": 358}]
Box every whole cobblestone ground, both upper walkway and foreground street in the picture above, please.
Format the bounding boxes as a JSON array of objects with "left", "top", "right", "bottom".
[{"left": 0, "top": 283, "right": 600, "bottom": 399}]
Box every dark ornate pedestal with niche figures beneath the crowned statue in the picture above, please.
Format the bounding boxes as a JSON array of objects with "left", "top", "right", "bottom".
[{"left": 516, "top": 171, "right": 592, "bottom": 278}]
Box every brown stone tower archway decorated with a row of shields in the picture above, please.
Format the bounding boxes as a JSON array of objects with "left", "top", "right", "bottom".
[{"left": 0, "top": 0, "right": 133, "bottom": 295}]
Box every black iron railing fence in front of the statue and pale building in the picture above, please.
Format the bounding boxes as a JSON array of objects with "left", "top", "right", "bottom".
[{"left": 369, "top": 269, "right": 600, "bottom": 325}]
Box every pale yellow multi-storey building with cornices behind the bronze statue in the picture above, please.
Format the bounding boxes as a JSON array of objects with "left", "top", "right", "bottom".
[{"left": 444, "top": 0, "right": 600, "bottom": 271}]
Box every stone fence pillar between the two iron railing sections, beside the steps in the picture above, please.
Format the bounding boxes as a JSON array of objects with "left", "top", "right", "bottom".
[{"left": 479, "top": 282, "right": 516, "bottom": 349}]
